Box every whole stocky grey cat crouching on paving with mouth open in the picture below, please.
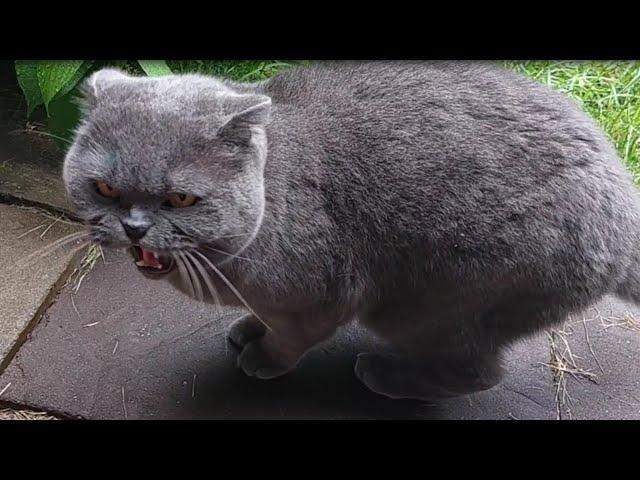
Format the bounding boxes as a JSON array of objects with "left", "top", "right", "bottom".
[{"left": 64, "top": 62, "right": 640, "bottom": 400}]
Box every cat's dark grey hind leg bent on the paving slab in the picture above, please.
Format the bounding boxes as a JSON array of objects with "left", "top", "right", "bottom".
[{"left": 355, "top": 296, "right": 569, "bottom": 401}]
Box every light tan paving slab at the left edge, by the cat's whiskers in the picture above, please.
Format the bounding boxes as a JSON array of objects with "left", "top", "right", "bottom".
[{"left": 0, "top": 204, "right": 84, "bottom": 372}]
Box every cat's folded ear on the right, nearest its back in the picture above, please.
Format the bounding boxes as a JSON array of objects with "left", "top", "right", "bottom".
[{"left": 218, "top": 95, "right": 271, "bottom": 144}]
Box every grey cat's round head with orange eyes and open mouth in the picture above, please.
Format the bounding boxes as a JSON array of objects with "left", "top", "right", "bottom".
[{"left": 63, "top": 69, "right": 271, "bottom": 273}]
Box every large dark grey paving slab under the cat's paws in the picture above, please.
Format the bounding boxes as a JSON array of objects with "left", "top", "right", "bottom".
[{"left": 0, "top": 248, "right": 555, "bottom": 419}]
